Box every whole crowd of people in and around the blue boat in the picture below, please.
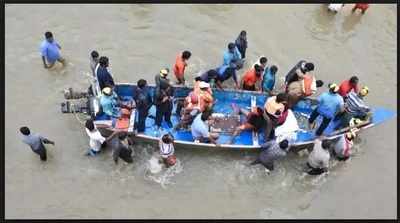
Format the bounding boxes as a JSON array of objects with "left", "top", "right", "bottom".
[{"left": 20, "top": 30, "right": 371, "bottom": 174}]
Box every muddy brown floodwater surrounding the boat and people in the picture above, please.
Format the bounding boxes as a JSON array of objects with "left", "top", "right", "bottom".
[{"left": 5, "top": 4, "right": 397, "bottom": 218}]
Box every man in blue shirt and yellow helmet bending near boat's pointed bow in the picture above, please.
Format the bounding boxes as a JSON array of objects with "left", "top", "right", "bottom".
[{"left": 308, "top": 84, "right": 344, "bottom": 136}]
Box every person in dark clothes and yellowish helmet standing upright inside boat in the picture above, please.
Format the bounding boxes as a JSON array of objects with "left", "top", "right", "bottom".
[{"left": 154, "top": 69, "right": 174, "bottom": 128}]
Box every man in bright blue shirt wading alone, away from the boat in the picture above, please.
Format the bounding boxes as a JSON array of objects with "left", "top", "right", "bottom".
[{"left": 40, "top": 32, "right": 65, "bottom": 69}]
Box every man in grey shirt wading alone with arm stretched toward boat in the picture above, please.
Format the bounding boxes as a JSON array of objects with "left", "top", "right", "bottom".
[{"left": 19, "top": 126, "right": 55, "bottom": 161}]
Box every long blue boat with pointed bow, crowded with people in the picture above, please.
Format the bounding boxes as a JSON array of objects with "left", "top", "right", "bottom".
[{"left": 83, "top": 83, "right": 395, "bottom": 150}]
